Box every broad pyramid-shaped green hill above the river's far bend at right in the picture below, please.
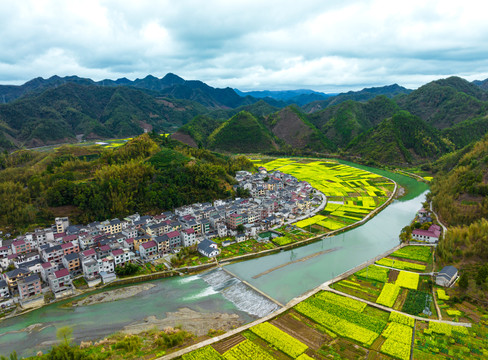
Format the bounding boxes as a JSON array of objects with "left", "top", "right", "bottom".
[{"left": 346, "top": 111, "right": 450, "bottom": 164}]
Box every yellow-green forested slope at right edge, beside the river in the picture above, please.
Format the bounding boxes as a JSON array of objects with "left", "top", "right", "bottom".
[{"left": 431, "top": 135, "right": 488, "bottom": 272}]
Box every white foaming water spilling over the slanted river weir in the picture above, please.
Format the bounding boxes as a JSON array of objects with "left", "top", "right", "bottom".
[{"left": 199, "top": 268, "right": 279, "bottom": 317}]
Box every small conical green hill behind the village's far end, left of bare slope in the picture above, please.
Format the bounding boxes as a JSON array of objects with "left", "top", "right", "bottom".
[{"left": 208, "top": 111, "right": 277, "bottom": 153}]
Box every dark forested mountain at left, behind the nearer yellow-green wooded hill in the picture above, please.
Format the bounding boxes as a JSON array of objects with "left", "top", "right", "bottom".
[{"left": 0, "top": 83, "right": 207, "bottom": 148}]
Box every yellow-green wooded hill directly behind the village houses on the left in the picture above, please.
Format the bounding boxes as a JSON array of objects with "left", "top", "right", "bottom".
[{"left": 0, "top": 133, "right": 252, "bottom": 230}]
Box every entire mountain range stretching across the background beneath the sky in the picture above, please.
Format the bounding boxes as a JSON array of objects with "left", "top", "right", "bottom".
[{"left": 0, "top": 74, "right": 488, "bottom": 164}]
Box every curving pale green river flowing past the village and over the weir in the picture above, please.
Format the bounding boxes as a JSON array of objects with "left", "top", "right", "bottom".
[{"left": 0, "top": 163, "right": 428, "bottom": 356}]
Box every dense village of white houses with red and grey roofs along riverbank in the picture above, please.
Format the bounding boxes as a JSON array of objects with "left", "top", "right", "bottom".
[{"left": 0, "top": 167, "right": 320, "bottom": 310}]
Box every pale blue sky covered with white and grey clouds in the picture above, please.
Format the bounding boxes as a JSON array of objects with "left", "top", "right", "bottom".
[{"left": 0, "top": 0, "right": 488, "bottom": 93}]
